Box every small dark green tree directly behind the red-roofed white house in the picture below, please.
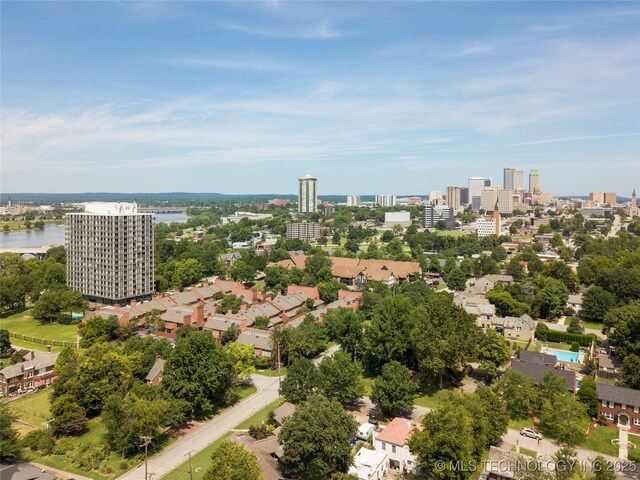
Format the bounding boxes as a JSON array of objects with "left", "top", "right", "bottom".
[{"left": 371, "top": 361, "right": 417, "bottom": 416}]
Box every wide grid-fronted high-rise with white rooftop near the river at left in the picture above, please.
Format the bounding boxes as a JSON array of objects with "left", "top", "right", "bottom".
[{"left": 66, "top": 203, "right": 155, "bottom": 304}]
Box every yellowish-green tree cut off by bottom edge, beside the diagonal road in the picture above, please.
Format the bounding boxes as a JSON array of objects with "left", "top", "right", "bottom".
[{"left": 203, "top": 440, "right": 262, "bottom": 480}]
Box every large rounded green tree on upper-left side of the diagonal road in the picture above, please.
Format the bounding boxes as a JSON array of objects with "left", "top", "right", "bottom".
[{"left": 162, "top": 331, "right": 233, "bottom": 415}]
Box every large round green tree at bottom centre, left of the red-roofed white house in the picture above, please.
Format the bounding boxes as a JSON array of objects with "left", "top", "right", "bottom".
[{"left": 278, "top": 395, "right": 357, "bottom": 480}]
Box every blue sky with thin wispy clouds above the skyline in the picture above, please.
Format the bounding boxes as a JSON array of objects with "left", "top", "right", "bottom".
[{"left": 0, "top": 1, "right": 640, "bottom": 196}]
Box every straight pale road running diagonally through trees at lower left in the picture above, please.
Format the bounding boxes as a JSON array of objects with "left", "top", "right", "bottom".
[{"left": 119, "top": 375, "right": 279, "bottom": 480}]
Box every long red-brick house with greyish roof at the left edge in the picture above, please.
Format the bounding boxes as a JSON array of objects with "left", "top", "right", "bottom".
[{"left": 0, "top": 350, "right": 60, "bottom": 397}]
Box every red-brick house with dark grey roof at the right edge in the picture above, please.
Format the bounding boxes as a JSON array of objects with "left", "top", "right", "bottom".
[{"left": 596, "top": 383, "right": 640, "bottom": 434}]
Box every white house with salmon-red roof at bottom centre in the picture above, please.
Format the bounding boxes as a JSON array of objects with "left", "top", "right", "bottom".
[{"left": 373, "top": 417, "right": 419, "bottom": 475}]
